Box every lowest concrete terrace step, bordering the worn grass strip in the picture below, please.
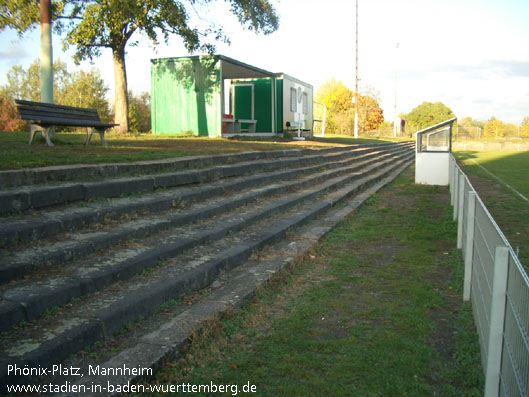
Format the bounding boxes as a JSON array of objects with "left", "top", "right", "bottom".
[{"left": 57, "top": 159, "right": 407, "bottom": 395}]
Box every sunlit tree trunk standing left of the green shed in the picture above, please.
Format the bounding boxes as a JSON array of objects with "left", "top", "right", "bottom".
[{"left": 112, "top": 46, "right": 129, "bottom": 133}]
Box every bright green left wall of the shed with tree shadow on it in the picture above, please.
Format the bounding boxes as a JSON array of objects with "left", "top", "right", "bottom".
[{"left": 151, "top": 56, "right": 221, "bottom": 137}]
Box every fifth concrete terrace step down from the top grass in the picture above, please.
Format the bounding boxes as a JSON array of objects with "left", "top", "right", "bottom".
[{"left": 0, "top": 147, "right": 412, "bottom": 331}]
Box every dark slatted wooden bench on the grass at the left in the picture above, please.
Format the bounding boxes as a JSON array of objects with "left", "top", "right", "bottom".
[{"left": 15, "top": 99, "right": 119, "bottom": 146}]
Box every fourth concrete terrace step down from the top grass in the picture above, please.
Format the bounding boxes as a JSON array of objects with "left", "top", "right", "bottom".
[{"left": 0, "top": 145, "right": 406, "bottom": 283}]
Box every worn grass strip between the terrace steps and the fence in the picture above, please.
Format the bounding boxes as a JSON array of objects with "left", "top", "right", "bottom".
[{"left": 144, "top": 168, "right": 483, "bottom": 396}]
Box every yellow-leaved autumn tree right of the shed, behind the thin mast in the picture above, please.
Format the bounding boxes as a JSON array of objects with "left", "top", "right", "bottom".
[{"left": 315, "top": 78, "right": 384, "bottom": 134}]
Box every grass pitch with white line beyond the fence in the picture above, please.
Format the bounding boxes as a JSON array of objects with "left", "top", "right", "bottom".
[{"left": 454, "top": 151, "right": 529, "bottom": 270}]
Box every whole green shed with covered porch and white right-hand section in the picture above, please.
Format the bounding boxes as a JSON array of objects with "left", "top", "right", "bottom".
[{"left": 151, "top": 55, "right": 313, "bottom": 138}]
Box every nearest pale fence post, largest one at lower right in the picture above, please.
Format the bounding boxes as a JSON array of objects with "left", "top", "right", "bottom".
[{"left": 484, "top": 247, "right": 509, "bottom": 397}]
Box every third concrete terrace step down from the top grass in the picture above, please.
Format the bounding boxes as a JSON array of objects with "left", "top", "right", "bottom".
[{"left": 0, "top": 146, "right": 404, "bottom": 247}]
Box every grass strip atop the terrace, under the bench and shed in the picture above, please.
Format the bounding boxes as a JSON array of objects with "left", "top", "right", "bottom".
[{"left": 0, "top": 132, "right": 408, "bottom": 170}]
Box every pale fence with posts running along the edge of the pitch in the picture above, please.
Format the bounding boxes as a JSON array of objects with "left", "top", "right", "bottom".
[{"left": 449, "top": 156, "right": 529, "bottom": 397}]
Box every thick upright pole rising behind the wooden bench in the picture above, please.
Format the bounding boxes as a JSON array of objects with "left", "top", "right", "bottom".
[{"left": 40, "top": 0, "right": 53, "bottom": 103}]
